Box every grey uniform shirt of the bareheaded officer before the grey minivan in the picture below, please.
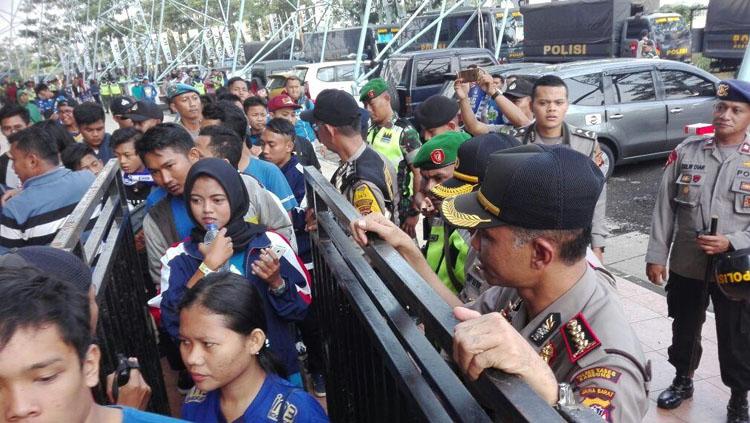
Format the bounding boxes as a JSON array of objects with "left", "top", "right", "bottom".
[{"left": 496, "top": 123, "right": 614, "bottom": 248}]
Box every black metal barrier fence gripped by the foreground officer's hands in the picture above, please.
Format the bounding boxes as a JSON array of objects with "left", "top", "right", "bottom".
[{"left": 305, "top": 167, "right": 601, "bottom": 423}]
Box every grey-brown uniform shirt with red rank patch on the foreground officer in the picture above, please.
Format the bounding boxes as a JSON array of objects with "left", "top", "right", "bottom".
[{"left": 467, "top": 266, "right": 650, "bottom": 422}]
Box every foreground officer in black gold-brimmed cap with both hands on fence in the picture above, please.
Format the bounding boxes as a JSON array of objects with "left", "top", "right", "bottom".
[{"left": 351, "top": 145, "right": 650, "bottom": 422}]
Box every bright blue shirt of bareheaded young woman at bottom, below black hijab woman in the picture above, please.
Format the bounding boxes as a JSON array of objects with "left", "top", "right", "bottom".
[{"left": 181, "top": 373, "right": 329, "bottom": 423}]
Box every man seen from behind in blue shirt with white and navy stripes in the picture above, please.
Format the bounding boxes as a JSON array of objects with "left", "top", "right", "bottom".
[{"left": 0, "top": 126, "right": 95, "bottom": 249}]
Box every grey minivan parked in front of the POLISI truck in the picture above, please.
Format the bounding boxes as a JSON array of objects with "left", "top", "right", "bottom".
[{"left": 514, "top": 59, "right": 719, "bottom": 174}]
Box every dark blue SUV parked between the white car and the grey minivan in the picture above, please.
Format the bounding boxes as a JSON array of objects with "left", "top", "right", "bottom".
[{"left": 380, "top": 48, "right": 498, "bottom": 117}]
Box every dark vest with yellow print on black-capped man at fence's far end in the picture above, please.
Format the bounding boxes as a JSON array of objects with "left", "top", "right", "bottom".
[{"left": 331, "top": 143, "right": 398, "bottom": 223}]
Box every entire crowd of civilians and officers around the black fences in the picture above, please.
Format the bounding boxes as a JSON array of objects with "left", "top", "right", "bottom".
[{"left": 0, "top": 60, "right": 750, "bottom": 422}]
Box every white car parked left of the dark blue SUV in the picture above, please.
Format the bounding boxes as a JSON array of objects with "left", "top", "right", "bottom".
[{"left": 294, "top": 60, "right": 370, "bottom": 100}]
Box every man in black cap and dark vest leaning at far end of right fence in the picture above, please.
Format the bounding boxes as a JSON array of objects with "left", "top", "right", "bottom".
[{"left": 300, "top": 89, "right": 399, "bottom": 222}]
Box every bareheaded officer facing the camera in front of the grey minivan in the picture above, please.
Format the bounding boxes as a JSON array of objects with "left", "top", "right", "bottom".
[{"left": 500, "top": 75, "right": 610, "bottom": 261}]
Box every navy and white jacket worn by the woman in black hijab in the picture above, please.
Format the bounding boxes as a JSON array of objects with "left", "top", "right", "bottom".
[{"left": 161, "top": 232, "right": 312, "bottom": 374}]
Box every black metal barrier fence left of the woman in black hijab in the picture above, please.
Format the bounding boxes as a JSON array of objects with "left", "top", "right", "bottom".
[{"left": 51, "top": 159, "right": 169, "bottom": 414}]
